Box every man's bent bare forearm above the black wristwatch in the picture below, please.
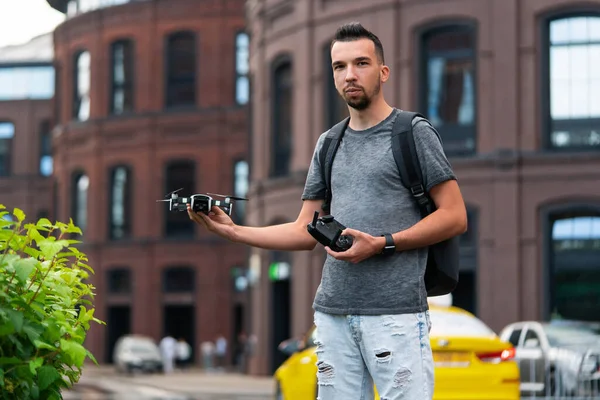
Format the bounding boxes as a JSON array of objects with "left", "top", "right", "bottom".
[{"left": 390, "top": 209, "right": 467, "bottom": 251}]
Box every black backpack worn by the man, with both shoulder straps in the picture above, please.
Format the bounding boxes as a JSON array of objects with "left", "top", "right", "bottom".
[{"left": 319, "top": 111, "right": 459, "bottom": 296}]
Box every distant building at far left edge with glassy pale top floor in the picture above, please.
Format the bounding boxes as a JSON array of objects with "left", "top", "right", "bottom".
[{"left": 0, "top": 34, "right": 54, "bottom": 228}]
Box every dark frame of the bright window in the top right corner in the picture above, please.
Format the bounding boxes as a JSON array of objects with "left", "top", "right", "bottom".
[{"left": 538, "top": 10, "right": 600, "bottom": 153}]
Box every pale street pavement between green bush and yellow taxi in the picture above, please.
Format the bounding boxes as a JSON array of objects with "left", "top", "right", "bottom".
[{"left": 63, "top": 365, "right": 274, "bottom": 400}]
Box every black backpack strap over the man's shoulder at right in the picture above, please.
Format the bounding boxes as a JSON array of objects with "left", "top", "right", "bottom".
[{"left": 392, "top": 111, "right": 433, "bottom": 217}]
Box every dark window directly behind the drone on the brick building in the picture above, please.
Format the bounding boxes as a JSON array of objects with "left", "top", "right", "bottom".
[{"left": 164, "top": 160, "right": 196, "bottom": 238}]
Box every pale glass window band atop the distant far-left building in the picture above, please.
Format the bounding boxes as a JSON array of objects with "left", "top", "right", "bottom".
[{"left": 0, "top": 65, "right": 54, "bottom": 100}]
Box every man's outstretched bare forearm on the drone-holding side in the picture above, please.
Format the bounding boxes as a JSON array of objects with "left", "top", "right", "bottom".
[{"left": 232, "top": 222, "right": 317, "bottom": 251}]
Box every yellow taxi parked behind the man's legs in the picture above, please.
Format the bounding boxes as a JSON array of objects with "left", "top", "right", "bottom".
[{"left": 274, "top": 301, "right": 520, "bottom": 400}]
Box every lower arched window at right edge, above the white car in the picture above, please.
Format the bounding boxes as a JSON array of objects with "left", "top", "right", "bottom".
[{"left": 548, "top": 207, "right": 600, "bottom": 321}]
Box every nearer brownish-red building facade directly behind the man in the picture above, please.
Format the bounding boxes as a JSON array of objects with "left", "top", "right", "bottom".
[{"left": 247, "top": 0, "right": 600, "bottom": 374}]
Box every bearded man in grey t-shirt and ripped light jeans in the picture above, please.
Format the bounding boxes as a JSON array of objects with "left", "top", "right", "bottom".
[{"left": 190, "top": 23, "right": 467, "bottom": 400}]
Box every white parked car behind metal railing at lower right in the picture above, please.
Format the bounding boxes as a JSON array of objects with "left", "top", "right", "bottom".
[{"left": 500, "top": 321, "right": 600, "bottom": 398}]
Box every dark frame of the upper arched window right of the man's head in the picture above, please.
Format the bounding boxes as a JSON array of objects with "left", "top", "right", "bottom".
[{"left": 414, "top": 18, "right": 480, "bottom": 158}]
